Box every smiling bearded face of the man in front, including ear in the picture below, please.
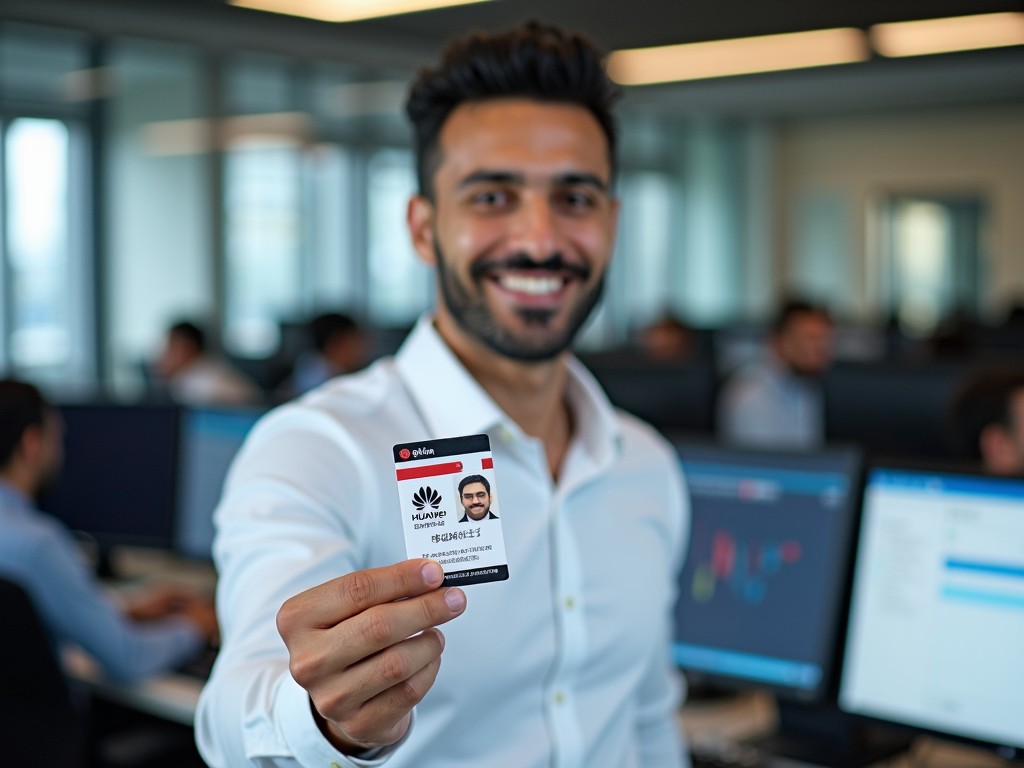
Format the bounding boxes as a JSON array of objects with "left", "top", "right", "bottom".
[{"left": 409, "top": 98, "right": 617, "bottom": 360}]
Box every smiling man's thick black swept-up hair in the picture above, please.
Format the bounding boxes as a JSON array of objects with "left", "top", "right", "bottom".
[{"left": 406, "top": 22, "right": 620, "bottom": 200}]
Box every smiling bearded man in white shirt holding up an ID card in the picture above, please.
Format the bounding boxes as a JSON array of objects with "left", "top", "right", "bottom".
[{"left": 197, "top": 24, "right": 687, "bottom": 768}]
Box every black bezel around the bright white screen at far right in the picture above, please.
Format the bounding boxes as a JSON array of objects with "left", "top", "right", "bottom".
[{"left": 836, "top": 458, "right": 1024, "bottom": 763}]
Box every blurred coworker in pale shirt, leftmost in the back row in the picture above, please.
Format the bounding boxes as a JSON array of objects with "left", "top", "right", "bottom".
[{"left": 155, "top": 321, "right": 262, "bottom": 406}]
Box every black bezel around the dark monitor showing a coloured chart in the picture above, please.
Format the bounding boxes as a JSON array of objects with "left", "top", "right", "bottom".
[{"left": 670, "top": 433, "right": 865, "bottom": 707}]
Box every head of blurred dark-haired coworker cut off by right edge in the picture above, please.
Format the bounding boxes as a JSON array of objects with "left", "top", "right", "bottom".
[{"left": 949, "top": 371, "right": 1024, "bottom": 475}]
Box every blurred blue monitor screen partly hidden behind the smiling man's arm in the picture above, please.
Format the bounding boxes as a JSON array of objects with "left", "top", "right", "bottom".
[{"left": 174, "top": 408, "right": 263, "bottom": 560}]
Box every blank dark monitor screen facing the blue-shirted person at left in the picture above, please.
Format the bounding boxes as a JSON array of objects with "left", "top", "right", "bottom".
[{"left": 40, "top": 404, "right": 178, "bottom": 548}]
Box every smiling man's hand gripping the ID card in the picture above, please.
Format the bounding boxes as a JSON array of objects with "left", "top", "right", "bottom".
[{"left": 278, "top": 560, "right": 466, "bottom": 755}]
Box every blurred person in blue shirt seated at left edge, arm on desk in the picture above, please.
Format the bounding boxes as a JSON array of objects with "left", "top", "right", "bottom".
[{"left": 0, "top": 379, "right": 217, "bottom": 681}]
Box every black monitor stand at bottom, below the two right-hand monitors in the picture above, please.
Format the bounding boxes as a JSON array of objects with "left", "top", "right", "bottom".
[{"left": 748, "top": 701, "right": 911, "bottom": 768}]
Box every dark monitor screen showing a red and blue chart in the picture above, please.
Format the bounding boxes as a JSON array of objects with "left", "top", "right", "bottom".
[{"left": 674, "top": 440, "right": 860, "bottom": 702}]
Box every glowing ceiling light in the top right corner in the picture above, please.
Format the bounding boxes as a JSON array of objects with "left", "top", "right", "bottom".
[{"left": 870, "top": 12, "right": 1024, "bottom": 56}]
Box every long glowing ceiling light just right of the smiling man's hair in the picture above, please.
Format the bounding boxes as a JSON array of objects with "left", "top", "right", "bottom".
[{"left": 608, "top": 29, "right": 868, "bottom": 85}]
